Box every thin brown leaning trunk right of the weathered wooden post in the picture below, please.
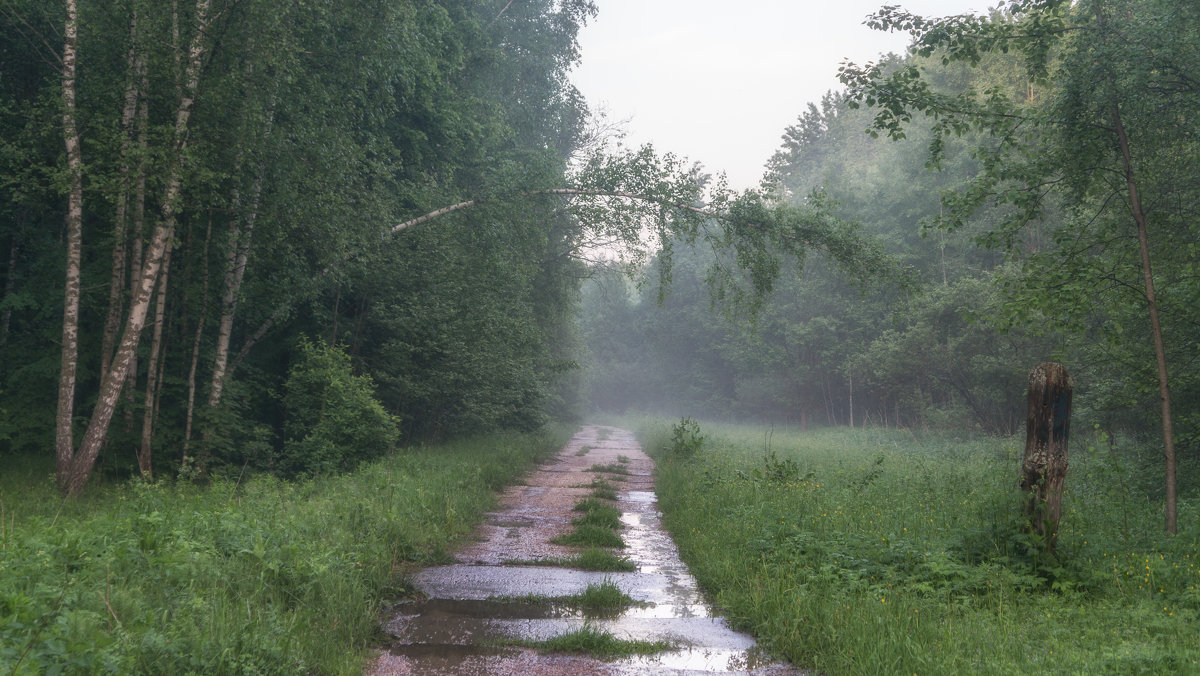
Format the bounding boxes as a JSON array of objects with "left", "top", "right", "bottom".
[{"left": 1112, "top": 104, "right": 1177, "bottom": 534}]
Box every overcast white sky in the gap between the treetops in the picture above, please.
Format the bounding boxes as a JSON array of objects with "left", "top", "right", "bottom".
[{"left": 574, "top": 0, "right": 998, "bottom": 189}]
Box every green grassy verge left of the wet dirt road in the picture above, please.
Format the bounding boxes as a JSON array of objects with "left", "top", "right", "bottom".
[{"left": 0, "top": 429, "right": 569, "bottom": 675}]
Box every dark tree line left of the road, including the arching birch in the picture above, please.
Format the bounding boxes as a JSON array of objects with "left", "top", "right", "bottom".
[{"left": 0, "top": 0, "right": 893, "bottom": 495}]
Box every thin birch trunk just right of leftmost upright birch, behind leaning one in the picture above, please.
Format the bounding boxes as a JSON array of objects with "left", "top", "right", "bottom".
[{"left": 100, "top": 12, "right": 144, "bottom": 379}]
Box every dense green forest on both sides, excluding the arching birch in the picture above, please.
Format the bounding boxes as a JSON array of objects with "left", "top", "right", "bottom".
[{"left": 0, "top": 0, "right": 1200, "bottom": 509}]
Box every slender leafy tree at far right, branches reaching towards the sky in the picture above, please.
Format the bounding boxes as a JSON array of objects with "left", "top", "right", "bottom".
[{"left": 841, "top": 0, "right": 1200, "bottom": 533}]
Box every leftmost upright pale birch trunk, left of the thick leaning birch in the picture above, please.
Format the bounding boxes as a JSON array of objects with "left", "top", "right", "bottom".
[{"left": 54, "top": 0, "right": 83, "bottom": 490}]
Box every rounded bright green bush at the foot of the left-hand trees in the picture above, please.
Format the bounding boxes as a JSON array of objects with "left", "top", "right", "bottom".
[{"left": 278, "top": 339, "right": 400, "bottom": 475}]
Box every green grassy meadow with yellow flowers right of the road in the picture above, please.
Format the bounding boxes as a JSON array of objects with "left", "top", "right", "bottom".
[{"left": 638, "top": 421, "right": 1200, "bottom": 674}]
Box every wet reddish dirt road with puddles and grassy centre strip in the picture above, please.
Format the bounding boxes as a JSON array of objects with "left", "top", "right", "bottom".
[{"left": 368, "top": 426, "right": 797, "bottom": 676}]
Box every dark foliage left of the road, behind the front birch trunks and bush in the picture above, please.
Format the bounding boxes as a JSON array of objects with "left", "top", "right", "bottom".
[{"left": 0, "top": 0, "right": 595, "bottom": 474}]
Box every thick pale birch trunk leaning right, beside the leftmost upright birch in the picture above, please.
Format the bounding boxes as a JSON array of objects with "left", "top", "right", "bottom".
[{"left": 64, "top": 0, "right": 210, "bottom": 496}]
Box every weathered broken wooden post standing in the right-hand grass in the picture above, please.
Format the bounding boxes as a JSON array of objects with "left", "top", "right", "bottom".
[{"left": 1021, "top": 361, "right": 1074, "bottom": 551}]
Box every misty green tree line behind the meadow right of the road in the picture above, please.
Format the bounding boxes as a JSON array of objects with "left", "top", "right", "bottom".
[{"left": 583, "top": 0, "right": 1200, "bottom": 532}]
